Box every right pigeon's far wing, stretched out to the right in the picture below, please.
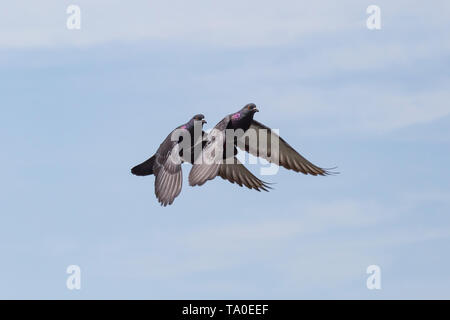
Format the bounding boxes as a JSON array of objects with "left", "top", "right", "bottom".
[{"left": 238, "top": 120, "right": 333, "bottom": 176}]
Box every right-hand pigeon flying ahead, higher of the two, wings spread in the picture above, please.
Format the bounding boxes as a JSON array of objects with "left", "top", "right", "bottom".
[{"left": 189, "top": 103, "right": 335, "bottom": 190}]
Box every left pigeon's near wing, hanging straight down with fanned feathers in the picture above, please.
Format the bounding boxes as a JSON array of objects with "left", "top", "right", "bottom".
[{"left": 154, "top": 139, "right": 183, "bottom": 207}]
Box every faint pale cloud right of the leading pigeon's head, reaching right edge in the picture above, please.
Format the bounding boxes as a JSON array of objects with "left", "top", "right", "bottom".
[{"left": 272, "top": 85, "right": 450, "bottom": 135}]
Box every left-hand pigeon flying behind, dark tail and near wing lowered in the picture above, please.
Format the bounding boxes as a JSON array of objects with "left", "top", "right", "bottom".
[{"left": 131, "top": 114, "right": 206, "bottom": 207}]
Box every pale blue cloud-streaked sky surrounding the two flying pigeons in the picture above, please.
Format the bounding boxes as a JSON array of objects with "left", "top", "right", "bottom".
[{"left": 0, "top": 0, "right": 450, "bottom": 299}]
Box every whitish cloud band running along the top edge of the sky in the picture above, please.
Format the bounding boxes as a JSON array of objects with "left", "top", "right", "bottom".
[{"left": 0, "top": 0, "right": 448, "bottom": 47}]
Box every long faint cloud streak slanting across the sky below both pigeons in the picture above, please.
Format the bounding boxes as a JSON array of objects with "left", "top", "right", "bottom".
[{"left": 102, "top": 201, "right": 391, "bottom": 277}]
